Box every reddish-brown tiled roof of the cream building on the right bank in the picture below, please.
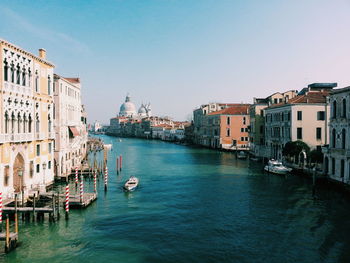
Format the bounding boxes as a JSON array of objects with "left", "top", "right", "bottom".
[{"left": 269, "top": 91, "right": 329, "bottom": 108}]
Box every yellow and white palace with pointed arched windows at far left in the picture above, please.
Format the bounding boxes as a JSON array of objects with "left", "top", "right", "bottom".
[{"left": 0, "top": 40, "right": 55, "bottom": 198}]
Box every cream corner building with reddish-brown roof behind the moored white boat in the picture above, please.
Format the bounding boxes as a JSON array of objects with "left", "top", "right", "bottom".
[{"left": 264, "top": 83, "right": 334, "bottom": 160}]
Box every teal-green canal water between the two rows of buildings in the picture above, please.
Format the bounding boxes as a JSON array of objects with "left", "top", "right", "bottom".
[{"left": 0, "top": 136, "right": 350, "bottom": 263}]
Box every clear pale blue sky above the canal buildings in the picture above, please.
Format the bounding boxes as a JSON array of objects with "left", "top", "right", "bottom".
[{"left": 0, "top": 0, "right": 350, "bottom": 124}]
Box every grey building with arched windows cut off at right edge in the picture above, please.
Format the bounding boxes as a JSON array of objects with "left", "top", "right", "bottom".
[{"left": 323, "top": 87, "right": 350, "bottom": 184}]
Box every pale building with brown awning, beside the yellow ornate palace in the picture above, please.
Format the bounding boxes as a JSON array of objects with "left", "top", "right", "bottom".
[{"left": 54, "top": 74, "right": 87, "bottom": 180}]
